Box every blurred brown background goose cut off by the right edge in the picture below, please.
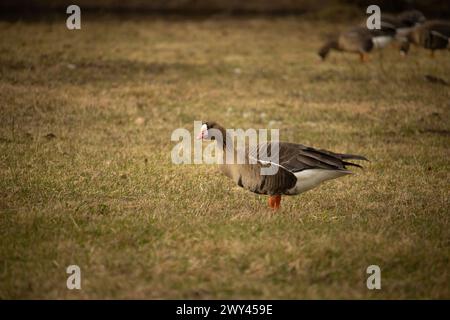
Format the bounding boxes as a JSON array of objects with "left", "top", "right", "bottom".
[{"left": 400, "top": 20, "right": 450, "bottom": 57}]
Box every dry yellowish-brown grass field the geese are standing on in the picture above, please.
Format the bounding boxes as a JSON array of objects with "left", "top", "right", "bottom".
[{"left": 0, "top": 17, "right": 450, "bottom": 299}]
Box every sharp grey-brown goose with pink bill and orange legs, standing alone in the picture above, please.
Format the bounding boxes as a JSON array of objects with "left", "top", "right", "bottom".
[{"left": 197, "top": 121, "right": 368, "bottom": 210}]
